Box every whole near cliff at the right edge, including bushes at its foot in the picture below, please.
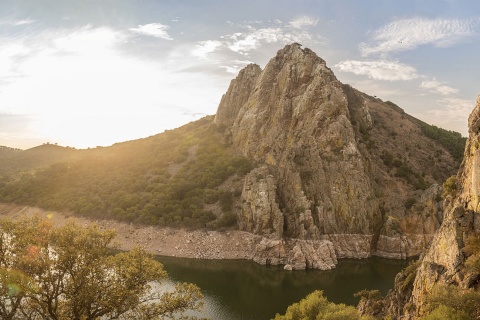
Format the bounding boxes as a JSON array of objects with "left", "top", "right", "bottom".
[{"left": 378, "top": 96, "right": 480, "bottom": 319}]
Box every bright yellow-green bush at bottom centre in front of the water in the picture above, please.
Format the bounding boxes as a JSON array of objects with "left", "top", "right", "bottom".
[{"left": 275, "top": 290, "right": 360, "bottom": 320}]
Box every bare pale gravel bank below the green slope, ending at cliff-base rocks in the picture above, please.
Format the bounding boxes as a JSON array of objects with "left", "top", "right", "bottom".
[{"left": 0, "top": 204, "right": 261, "bottom": 260}]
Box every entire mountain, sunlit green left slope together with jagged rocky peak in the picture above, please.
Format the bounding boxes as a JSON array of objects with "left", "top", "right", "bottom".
[{"left": 0, "top": 44, "right": 465, "bottom": 269}]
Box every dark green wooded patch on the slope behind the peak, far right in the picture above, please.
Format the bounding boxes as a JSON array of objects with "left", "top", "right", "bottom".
[{"left": 420, "top": 122, "right": 467, "bottom": 161}]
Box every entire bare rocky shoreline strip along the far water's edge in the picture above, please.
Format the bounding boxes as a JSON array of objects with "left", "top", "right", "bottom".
[{"left": 0, "top": 204, "right": 428, "bottom": 270}]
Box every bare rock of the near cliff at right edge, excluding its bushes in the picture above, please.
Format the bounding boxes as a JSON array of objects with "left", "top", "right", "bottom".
[{"left": 386, "top": 96, "right": 480, "bottom": 319}]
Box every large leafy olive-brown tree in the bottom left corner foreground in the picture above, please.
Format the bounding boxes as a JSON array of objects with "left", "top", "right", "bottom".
[{"left": 0, "top": 218, "right": 202, "bottom": 320}]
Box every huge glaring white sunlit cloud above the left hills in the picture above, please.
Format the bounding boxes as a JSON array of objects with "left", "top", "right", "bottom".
[{"left": 0, "top": 26, "right": 229, "bottom": 148}]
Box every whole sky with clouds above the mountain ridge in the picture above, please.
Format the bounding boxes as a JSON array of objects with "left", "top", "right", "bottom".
[{"left": 0, "top": 0, "right": 480, "bottom": 149}]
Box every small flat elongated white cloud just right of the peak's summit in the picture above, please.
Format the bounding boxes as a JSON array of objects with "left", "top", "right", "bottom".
[{"left": 335, "top": 60, "right": 418, "bottom": 81}]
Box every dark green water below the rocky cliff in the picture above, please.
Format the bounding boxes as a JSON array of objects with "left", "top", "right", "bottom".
[{"left": 158, "top": 257, "right": 408, "bottom": 320}]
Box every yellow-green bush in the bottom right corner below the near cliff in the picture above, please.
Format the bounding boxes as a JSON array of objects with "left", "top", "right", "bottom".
[{"left": 423, "top": 285, "right": 480, "bottom": 320}]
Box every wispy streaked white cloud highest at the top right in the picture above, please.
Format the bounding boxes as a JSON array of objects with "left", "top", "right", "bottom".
[{"left": 359, "top": 18, "right": 480, "bottom": 56}]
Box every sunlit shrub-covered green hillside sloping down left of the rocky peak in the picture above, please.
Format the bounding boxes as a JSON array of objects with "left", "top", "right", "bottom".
[{"left": 0, "top": 118, "right": 251, "bottom": 228}]
